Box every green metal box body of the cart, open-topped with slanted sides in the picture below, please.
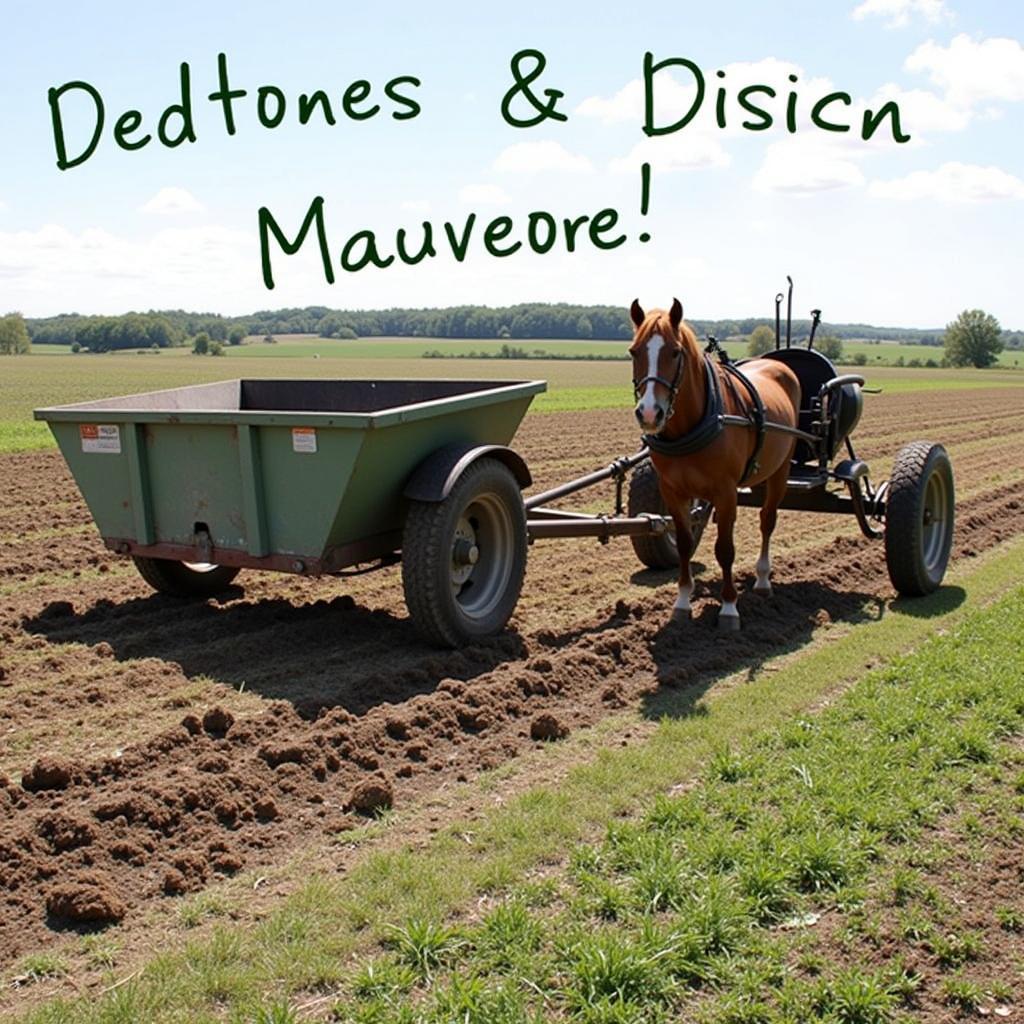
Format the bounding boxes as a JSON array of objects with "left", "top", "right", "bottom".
[{"left": 35, "top": 380, "right": 547, "bottom": 573}]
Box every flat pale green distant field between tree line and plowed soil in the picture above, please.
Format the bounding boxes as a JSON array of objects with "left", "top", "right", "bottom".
[{"left": 0, "top": 338, "right": 1024, "bottom": 452}]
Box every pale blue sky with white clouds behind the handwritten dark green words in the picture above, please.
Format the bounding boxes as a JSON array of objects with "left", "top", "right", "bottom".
[{"left": 0, "top": 0, "right": 1024, "bottom": 329}]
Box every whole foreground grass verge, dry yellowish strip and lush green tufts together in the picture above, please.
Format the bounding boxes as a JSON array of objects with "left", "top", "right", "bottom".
[{"left": 14, "top": 542, "right": 1024, "bottom": 1024}]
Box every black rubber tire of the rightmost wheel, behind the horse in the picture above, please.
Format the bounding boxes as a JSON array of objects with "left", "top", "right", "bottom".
[{"left": 886, "top": 441, "right": 955, "bottom": 597}]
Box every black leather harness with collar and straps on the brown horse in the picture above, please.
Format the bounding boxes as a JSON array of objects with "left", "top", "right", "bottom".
[{"left": 633, "top": 350, "right": 765, "bottom": 483}]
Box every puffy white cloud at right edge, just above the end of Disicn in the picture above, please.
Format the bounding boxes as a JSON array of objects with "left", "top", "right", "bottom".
[{"left": 904, "top": 34, "right": 1024, "bottom": 108}]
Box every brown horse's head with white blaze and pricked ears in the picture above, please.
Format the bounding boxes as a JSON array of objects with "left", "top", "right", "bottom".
[{"left": 630, "top": 299, "right": 695, "bottom": 434}]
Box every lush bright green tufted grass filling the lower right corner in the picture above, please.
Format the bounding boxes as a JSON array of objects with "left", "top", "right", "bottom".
[{"left": 334, "top": 589, "right": 1024, "bottom": 1024}]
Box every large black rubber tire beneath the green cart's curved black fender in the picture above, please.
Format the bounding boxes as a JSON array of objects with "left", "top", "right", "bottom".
[{"left": 401, "top": 457, "right": 527, "bottom": 647}]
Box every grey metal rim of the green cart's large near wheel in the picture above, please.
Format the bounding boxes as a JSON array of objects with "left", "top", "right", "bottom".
[{"left": 450, "top": 494, "right": 514, "bottom": 620}]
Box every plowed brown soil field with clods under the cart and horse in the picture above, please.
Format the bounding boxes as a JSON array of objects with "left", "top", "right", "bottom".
[{"left": 0, "top": 388, "right": 1024, "bottom": 962}]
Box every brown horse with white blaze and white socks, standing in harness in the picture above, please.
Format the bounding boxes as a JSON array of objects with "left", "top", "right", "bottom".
[{"left": 630, "top": 299, "right": 800, "bottom": 630}]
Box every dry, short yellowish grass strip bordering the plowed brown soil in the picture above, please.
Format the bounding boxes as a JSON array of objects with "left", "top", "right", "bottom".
[{"left": 14, "top": 541, "right": 1024, "bottom": 1022}]
